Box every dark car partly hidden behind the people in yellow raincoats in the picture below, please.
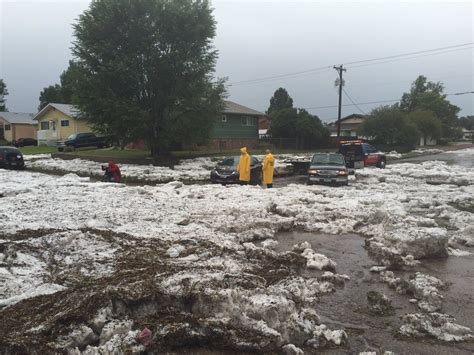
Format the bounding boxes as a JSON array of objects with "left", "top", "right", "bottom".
[{"left": 211, "top": 156, "right": 262, "bottom": 185}]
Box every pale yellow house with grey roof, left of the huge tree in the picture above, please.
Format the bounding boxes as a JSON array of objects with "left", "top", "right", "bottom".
[{"left": 33, "top": 103, "right": 92, "bottom": 146}]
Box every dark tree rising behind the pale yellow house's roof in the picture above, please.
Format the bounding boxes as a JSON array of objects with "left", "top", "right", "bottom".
[{"left": 38, "top": 61, "right": 77, "bottom": 111}]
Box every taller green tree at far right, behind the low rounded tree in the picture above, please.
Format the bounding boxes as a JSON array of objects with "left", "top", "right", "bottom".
[{"left": 400, "top": 75, "right": 460, "bottom": 138}]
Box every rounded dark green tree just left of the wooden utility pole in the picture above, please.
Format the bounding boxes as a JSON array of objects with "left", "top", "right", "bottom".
[{"left": 269, "top": 108, "right": 329, "bottom": 148}]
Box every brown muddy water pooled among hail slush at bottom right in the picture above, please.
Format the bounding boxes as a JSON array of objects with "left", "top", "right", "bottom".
[{"left": 277, "top": 232, "right": 474, "bottom": 355}]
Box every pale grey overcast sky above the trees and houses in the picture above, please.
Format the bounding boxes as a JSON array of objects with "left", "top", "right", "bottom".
[{"left": 0, "top": 0, "right": 474, "bottom": 121}]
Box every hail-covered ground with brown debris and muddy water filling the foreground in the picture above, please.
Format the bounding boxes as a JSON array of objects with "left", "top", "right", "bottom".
[{"left": 0, "top": 149, "right": 474, "bottom": 354}]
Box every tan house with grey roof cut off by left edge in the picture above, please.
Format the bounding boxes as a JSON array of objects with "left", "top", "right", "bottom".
[{"left": 0, "top": 112, "right": 36, "bottom": 142}]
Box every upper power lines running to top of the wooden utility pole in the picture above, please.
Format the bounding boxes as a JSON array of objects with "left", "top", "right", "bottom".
[{"left": 229, "top": 42, "right": 474, "bottom": 86}]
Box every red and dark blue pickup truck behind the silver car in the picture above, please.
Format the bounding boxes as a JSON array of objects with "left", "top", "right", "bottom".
[{"left": 339, "top": 140, "right": 387, "bottom": 169}]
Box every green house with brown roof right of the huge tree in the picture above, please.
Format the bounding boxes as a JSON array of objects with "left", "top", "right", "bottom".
[{"left": 211, "top": 101, "right": 265, "bottom": 150}]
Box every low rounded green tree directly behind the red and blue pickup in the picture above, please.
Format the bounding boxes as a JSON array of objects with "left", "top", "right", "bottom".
[{"left": 361, "top": 105, "right": 419, "bottom": 146}]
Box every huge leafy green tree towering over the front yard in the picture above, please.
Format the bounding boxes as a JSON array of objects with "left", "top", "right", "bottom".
[{"left": 73, "top": 0, "right": 224, "bottom": 156}]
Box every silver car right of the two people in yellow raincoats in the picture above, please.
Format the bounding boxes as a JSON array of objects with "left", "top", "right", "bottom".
[{"left": 308, "top": 153, "right": 349, "bottom": 185}]
